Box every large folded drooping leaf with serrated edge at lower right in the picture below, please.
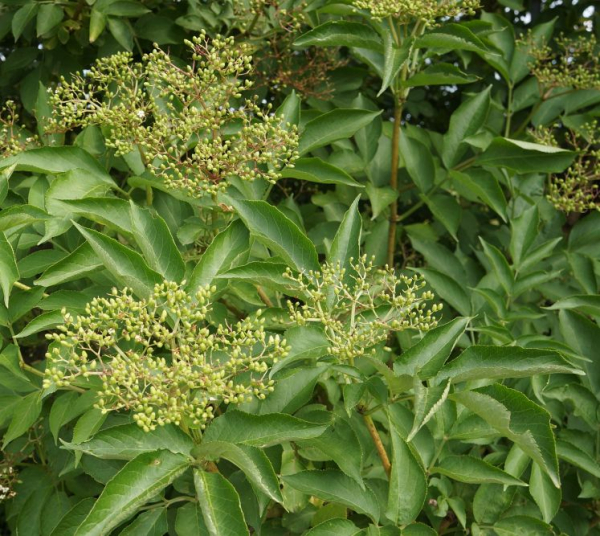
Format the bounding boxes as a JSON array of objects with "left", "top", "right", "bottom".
[{"left": 450, "top": 384, "right": 560, "bottom": 487}]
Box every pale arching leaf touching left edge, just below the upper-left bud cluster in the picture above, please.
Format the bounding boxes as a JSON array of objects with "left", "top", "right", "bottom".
[{"left": 0, "top": 146, "right": 115, "bottom": 186}]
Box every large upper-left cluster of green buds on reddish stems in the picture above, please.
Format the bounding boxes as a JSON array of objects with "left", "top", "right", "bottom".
[{"left": 49, "top": 33, "right": 298, "bottom": 197}]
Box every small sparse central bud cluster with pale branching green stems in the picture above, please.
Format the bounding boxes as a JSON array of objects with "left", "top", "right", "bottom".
[{"left": 286, "top": 256, "right": 442, "bottom": 362}]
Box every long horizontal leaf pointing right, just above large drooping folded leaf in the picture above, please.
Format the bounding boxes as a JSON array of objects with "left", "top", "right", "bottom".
[{"left": 435, "top": 346, "right": 583, "bottom": 383}]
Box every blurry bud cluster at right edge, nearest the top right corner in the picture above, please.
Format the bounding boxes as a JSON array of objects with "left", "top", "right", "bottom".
[{"left": 528, "top": 33, "right": 600, "bottom": 92}]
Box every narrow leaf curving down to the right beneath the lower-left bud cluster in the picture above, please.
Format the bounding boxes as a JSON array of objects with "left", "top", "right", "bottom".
[{"left": 193, "top": 441, "right": 283, "bottom": 503}]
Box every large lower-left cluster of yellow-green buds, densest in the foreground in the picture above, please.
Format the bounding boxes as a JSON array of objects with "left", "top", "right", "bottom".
[{"left": 45, "top": 282, "right": 288, "bottom": 431}]
